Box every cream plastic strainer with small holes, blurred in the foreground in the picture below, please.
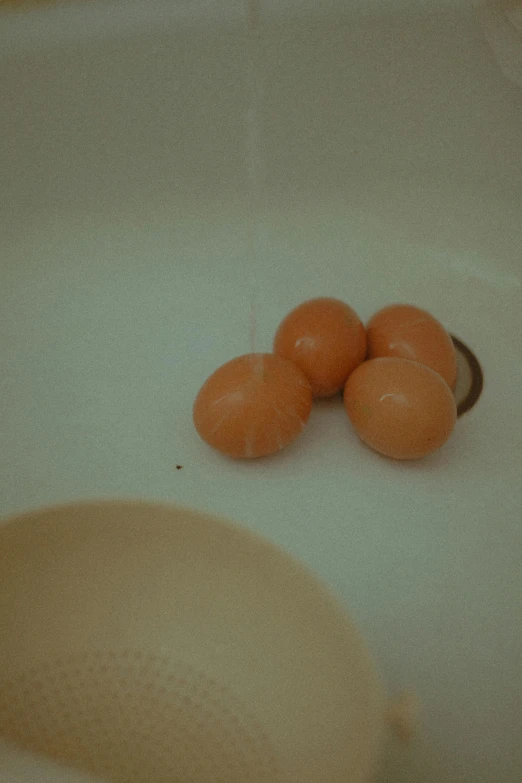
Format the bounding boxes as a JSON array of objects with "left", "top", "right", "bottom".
[{"left": 0, "top": 502, "right": 384, "bottom": 783}]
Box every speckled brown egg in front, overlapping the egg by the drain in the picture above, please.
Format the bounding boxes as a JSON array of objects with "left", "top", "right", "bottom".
[{"left": 344, "top": 358, "right": 457, "bottom": 459}]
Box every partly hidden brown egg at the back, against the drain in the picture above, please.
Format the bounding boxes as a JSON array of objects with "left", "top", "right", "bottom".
[{"left": 367, "top": 304, "right": 457, "bottom": 389}]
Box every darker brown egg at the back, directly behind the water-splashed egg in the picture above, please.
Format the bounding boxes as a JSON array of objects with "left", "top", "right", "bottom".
[{"left": 274, "top": 297, "right": 366, "bottom": 397}]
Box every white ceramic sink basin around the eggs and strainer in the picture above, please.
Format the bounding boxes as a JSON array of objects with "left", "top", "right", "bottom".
[{"left": 0, "top": 0, "right": 522, "bottom": 783}]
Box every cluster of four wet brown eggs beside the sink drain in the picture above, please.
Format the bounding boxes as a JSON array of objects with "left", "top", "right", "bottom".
[{"left": 193, "top": 297, "right": 457, "bottom": 459}]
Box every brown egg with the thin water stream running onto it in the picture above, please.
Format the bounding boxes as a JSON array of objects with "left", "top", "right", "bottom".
[{"left": 193, "top": 353, "right": 312, "bottom": 458}]
